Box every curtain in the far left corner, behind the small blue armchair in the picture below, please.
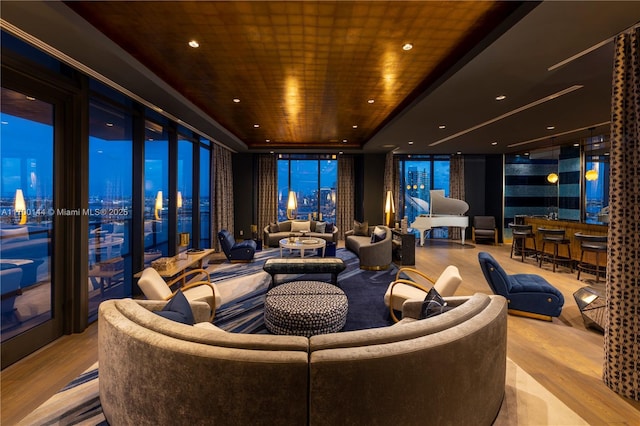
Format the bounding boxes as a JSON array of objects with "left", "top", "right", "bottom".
[{"left": 211, "top": 145, "right": 233, "bottom": 251}]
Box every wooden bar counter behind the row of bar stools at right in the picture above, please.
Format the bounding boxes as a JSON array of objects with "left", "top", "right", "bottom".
[{"left": 524, "top": 217, "right": 609, "bottom": 265}]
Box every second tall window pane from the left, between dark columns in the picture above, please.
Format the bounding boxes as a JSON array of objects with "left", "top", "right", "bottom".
[{"left": 88, "top": 100, "right": 133, "bottom": 320}]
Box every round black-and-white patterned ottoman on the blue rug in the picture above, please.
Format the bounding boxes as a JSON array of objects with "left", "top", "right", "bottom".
[{"left": 264, "top": 281, "right": 349, "bottom": 337}]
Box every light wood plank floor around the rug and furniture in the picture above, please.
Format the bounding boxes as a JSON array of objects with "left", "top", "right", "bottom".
[{"left": 0, "top": 240, "right": 640, "bottom": 425}]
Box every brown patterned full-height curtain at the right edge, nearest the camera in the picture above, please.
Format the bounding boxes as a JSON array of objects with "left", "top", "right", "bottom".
[{"left": 603, "top": 28, "right": 640, "bottom": 401}]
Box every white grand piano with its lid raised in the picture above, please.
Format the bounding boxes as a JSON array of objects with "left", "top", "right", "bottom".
[{"left": 411, "top": 189, "right": 469, "bottom": 246}]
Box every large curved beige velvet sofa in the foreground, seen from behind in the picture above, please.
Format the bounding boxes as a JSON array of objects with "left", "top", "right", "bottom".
[{"left": 98, "top": 293, "right": 507, "bottom": 425}]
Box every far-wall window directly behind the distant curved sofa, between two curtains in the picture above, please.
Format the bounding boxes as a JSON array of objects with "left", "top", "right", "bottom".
[{"left": 278, "top": 154, "right": 338, "bottom": 223}]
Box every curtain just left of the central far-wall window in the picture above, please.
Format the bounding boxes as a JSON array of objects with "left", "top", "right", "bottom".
[{"left": 257, "top": 154, "right": 276, "bottom": 243}]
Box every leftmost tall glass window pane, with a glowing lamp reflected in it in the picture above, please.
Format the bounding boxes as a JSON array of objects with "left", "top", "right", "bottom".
[{"left": 0, "top": 87, "right": 55, "bottom": 342}]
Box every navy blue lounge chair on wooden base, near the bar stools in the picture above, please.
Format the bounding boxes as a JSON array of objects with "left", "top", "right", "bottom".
[{"left": 478, "top": 252, "right": 564, "bottom": 321}]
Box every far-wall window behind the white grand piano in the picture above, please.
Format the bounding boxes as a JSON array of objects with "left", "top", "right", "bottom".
[{"left": 398, "top": 155, "right": 450, "bottom": 238}]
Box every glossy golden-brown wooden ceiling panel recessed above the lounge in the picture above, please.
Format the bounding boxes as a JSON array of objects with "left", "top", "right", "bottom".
[{"left": 65, "top": 1, "right": 520, "bottom": 149}]
